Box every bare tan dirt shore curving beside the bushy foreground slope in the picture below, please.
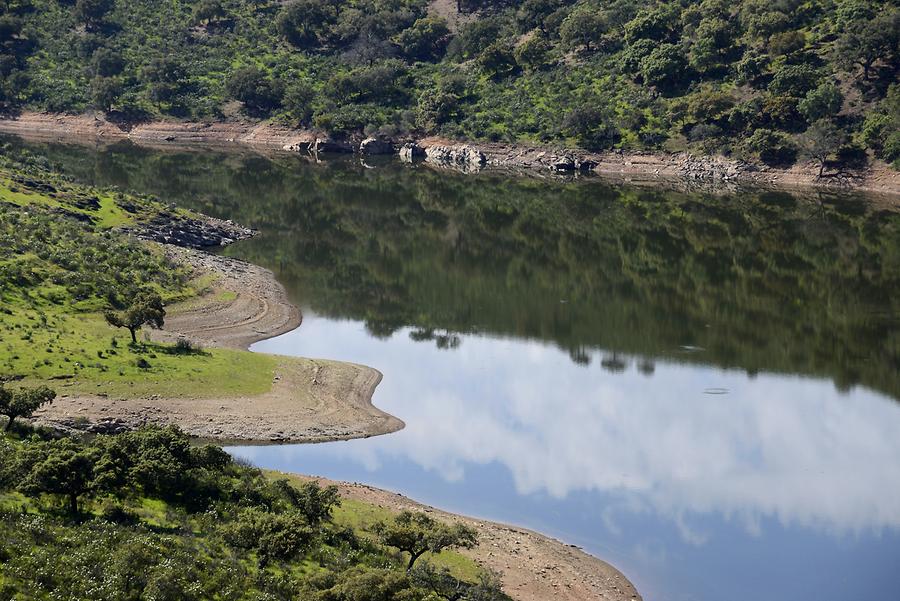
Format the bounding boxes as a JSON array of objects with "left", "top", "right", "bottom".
[{"left": 288, "top": 476, "right": 641, "bottom": 601}]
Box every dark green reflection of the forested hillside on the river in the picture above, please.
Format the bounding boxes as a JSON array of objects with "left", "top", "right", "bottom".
[{"left": 22, "top": 140, "right": 900, "bottom": 398}]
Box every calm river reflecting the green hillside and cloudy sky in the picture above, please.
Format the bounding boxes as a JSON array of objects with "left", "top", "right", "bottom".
[{"left": 7, "top": 140, "right": 900, "bottom": 601}]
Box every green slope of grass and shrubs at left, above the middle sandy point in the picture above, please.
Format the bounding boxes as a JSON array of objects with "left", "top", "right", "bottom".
[{"left": 0, "top": 149, "right": 277, "bottom": 396}]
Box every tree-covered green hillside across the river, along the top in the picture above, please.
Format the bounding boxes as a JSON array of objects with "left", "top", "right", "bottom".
[{"left": 0, "top": 0, "right": 900, "bottom": 164}]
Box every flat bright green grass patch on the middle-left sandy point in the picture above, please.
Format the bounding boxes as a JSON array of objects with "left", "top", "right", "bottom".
[{"left": 0, "top": 296, "right": 279, "bottom": 398}]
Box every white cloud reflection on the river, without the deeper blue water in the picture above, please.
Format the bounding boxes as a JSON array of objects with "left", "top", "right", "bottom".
[{"left": 255, "top": 315, "right": 900, "bottom": 544}]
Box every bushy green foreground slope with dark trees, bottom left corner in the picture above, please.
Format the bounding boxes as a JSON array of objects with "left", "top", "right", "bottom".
[{"left": 0, "top": 428, "right": 506, "bottom": 601}]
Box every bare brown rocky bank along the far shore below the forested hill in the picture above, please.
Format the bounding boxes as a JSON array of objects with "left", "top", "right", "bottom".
[{"left": 0, "top": 112, "right": 900, "bottom": 196}]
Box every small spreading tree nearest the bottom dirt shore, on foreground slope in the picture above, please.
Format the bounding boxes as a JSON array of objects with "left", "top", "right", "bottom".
[{"left": 374, "top": 511, "right": 477, "bottom": 572}]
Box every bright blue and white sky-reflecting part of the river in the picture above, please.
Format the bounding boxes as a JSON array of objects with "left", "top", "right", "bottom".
[{"left": 231, "top": 309, "right": 900, "bottom": 601}]
